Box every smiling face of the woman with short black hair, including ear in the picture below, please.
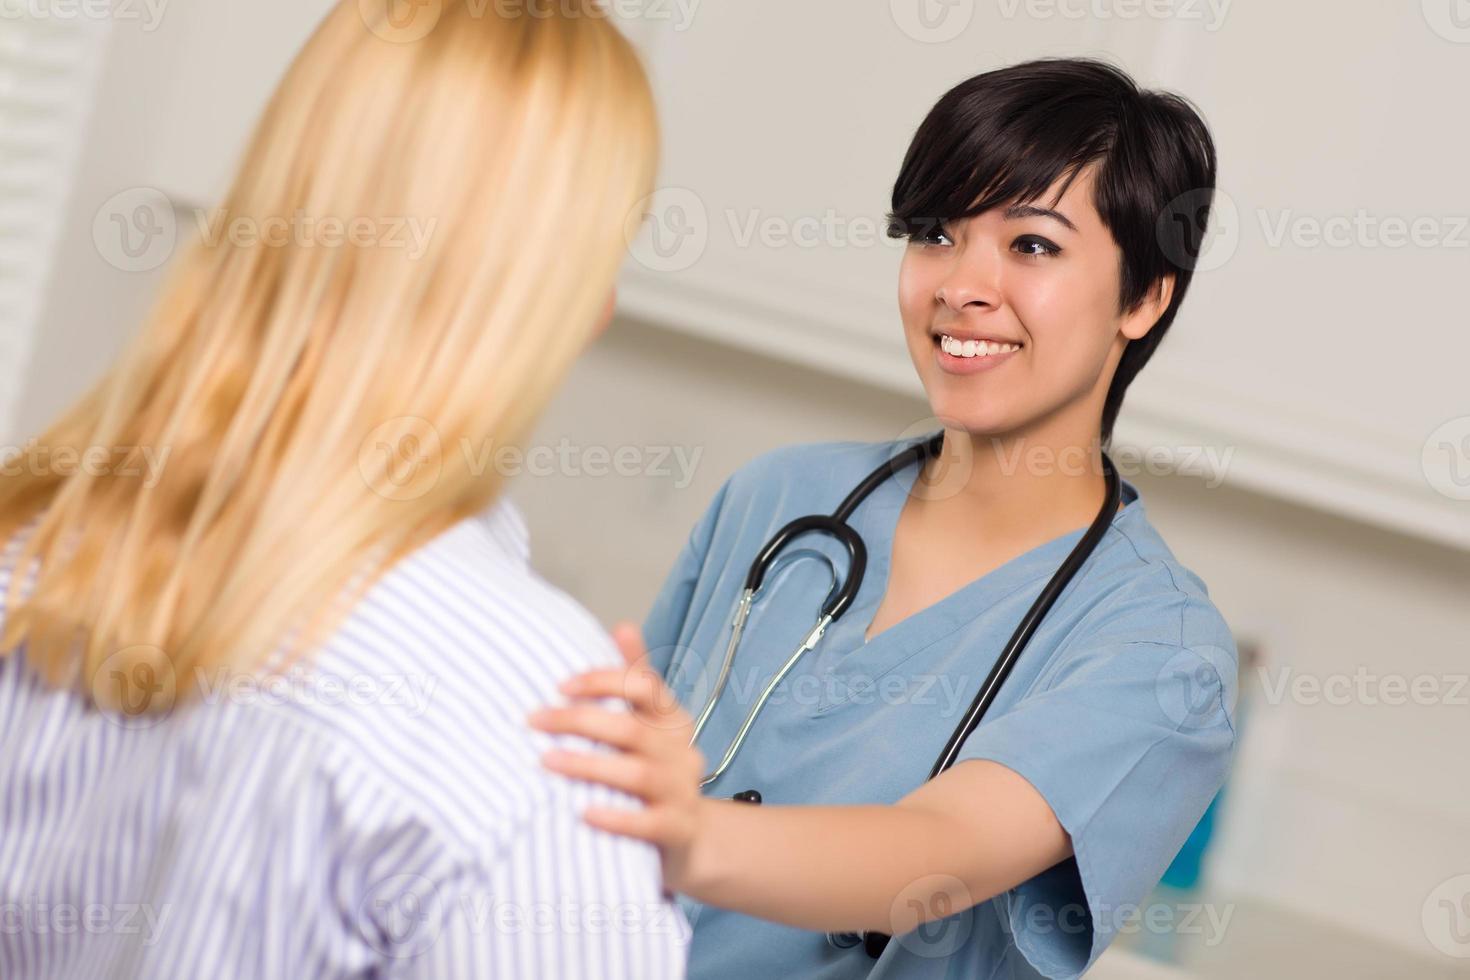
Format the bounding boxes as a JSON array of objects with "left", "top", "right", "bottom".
[{"left": 898, "top": 167, "right": 1157, "bottom": 439}]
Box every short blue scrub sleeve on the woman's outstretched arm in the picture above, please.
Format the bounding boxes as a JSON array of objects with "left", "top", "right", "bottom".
[{"left": 957, "top": 630, "right": 1238, "bottom": 977}]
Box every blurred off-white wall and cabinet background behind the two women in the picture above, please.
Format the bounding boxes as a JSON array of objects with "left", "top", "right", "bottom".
[{"left": 0, "top": 0, "right": 1470, "bottom": 979}]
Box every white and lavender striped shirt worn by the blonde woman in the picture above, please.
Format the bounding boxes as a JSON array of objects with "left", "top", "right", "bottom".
[{"left": 0, "top": 501, "right": 689, "bottom": 980}]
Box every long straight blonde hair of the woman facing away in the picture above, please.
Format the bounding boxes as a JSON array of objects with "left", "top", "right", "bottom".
[{"left": 0, "top": 0, "right": 657, "bottom": 707}]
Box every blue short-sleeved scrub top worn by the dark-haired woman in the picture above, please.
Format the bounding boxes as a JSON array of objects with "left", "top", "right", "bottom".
[{"left": 644, "top": 436, "right": 1238, "bottom": 980}]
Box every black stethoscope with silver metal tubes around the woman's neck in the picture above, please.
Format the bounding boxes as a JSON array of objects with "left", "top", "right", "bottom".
[{"left": 689, "top": 432, "right": 1123, "bottom": 959}]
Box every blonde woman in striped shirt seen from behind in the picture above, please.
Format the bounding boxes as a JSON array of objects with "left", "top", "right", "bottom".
[{"left": 0, "top": 0, "right": 686, "bottom": 980}]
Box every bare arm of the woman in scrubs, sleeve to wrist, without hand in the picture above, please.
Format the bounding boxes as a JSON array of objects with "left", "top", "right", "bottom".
[{"left": 679, "top": 760, "right": 1072, "bottom": 933}]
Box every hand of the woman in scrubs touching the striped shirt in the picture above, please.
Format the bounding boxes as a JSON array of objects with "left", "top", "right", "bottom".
[{"left": 526, "top": 623, "right": 704, "bottom": 892}]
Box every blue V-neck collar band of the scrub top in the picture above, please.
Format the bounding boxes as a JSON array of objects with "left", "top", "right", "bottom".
[{"left": 814, "top": 436, "right": 1142, "bottom": 714}]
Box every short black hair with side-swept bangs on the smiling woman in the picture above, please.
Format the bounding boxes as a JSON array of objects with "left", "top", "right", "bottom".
[{"left": 888, "top": 57, "right": 1216, "bottom": 447}]
